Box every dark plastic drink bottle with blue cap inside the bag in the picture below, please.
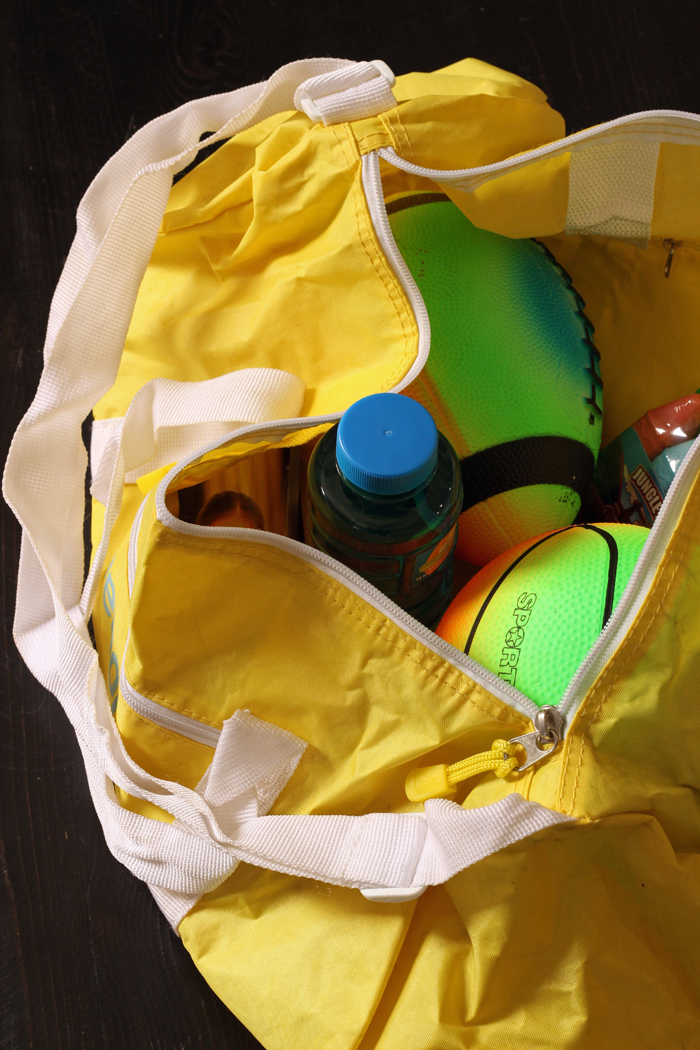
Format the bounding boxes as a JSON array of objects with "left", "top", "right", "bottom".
[{"left": 307, "top": 394, "right": 462, "bottom": 627}]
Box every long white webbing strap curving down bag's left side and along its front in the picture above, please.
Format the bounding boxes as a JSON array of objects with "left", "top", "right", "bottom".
[{"left": 3, "top": 59, "right": 566, "bottom": 928}]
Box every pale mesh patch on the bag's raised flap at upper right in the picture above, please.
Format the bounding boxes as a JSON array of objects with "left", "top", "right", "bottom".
[{"left": 566, "top": 139, "right": 659, "bottom": 248}]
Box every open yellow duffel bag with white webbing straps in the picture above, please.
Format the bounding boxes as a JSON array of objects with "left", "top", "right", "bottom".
[{"left": 4, "top": 59, "right": 700, "bottom": 1050}]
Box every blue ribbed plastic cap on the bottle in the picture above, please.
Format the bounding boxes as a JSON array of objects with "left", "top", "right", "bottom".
[{"left": 336, "top": 394, "right": 438, "bottom": 496}]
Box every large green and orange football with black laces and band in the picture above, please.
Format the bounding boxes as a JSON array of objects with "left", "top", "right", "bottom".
[{"left": 386, "top": 192, "right": 602, "bottom": 565}]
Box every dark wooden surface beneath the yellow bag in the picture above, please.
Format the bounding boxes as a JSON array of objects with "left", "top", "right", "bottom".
[{"left": 0, "top": 0, "right": 700, "bottom": 1050}]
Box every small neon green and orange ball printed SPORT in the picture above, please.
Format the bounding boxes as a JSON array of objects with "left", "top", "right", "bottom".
[{"left": 437, "top": 523, "right": 649, "bottom": 706}]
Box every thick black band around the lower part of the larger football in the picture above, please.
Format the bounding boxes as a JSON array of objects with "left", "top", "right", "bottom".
[{"left": 460, "top": 435, "right": 595, "bottom": 513}]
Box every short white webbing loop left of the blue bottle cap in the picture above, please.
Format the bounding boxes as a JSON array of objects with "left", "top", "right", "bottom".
[{"left": 90, "top": 369, "right": 306, "bottom": 505}]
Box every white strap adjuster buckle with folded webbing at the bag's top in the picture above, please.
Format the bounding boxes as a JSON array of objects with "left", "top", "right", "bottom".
[{"left": 294, "top": 60, "right": 398, "bottom": 127}]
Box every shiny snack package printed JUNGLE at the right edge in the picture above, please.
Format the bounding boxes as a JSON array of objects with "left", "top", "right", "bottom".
[{"left": 585, "top": 392, "right": 700, "bottom": 526}]
